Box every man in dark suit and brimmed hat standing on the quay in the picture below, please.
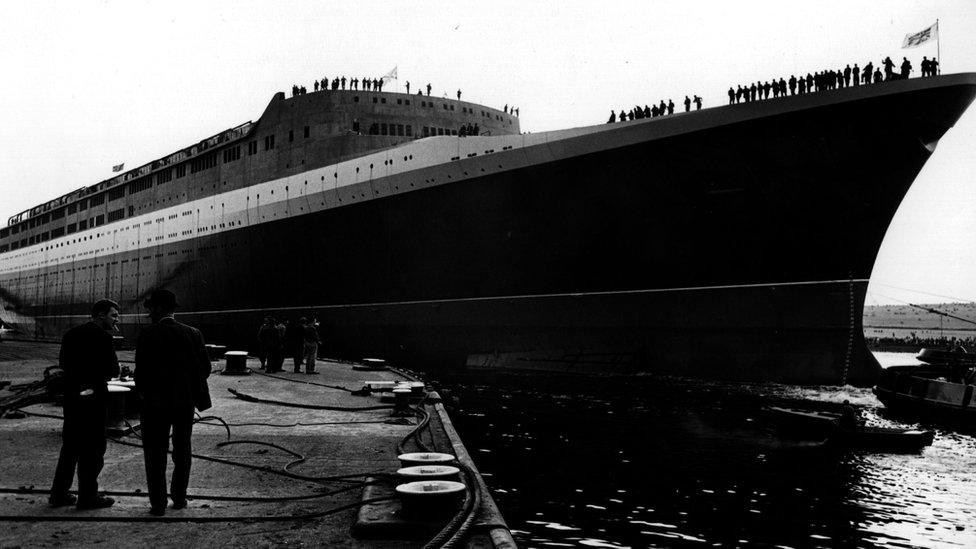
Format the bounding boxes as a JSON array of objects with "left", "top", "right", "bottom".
[{"left": 133, "top": 290, "right": 211, "bottom": 516}]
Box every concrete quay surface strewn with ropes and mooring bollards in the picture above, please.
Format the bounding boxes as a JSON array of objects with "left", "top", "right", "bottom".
[{"left": 0, "top": 340, "right": 515, "bottom": 548}]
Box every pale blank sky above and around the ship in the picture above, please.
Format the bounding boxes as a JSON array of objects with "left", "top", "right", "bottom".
[{"left": 0, "top": 0, "right": 976, "bottom": 304}]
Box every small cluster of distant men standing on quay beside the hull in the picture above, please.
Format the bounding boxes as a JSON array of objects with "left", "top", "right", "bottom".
[{"left": 258, "top": 316, "right": 322, "bottom": 374}]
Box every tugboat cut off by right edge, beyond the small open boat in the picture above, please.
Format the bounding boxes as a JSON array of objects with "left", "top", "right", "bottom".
[{"left": 874, "top": 347, "right": 976, "bottom": 426}]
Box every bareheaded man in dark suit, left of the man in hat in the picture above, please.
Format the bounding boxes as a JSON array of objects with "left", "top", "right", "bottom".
[{"left": 48, "top": 299, "right": 119, "bottom": 509}]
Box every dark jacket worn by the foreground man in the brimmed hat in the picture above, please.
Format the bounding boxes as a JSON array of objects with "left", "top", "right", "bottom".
[{"left": 133, "top": 317, "right": 211, "bottom": 413}]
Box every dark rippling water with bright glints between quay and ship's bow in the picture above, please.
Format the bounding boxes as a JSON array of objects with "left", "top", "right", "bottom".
[{"left": 441, "top": 355, "right": 976, "bottom": 547}]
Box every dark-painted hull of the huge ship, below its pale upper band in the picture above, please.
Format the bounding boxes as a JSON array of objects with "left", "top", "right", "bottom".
[{"left": 3, "top": 75, "right": 976, "bottom": 385}]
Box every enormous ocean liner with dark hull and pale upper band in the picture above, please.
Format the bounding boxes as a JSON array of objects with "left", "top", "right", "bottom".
[{"left": 0, "top": 74, "right": 976, "bottom": 384}]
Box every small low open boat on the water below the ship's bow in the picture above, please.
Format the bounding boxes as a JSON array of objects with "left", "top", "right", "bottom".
[{"left": 767, "top": 406, "right": 935, "bottom": 452}]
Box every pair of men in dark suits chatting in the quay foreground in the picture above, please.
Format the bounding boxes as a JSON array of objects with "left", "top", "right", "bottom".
[{"left": 48, "top": 290, "right": 211, "bottom": 516}]
